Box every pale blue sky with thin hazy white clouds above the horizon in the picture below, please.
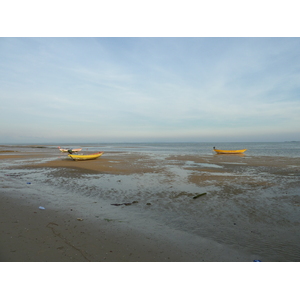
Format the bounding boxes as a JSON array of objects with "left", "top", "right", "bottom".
[{"left": 0, "top": 37, "right": 300, "bottom": 144}]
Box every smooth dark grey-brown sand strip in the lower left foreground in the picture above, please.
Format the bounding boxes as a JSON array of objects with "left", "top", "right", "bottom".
[{"left": 0, "top": 194, "right": 252, "bottom": 262}]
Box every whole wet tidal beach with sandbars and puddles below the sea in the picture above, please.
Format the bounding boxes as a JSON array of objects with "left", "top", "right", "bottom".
[{"left": 0, "top": 147, "right": 300, "bottom": 262}]
